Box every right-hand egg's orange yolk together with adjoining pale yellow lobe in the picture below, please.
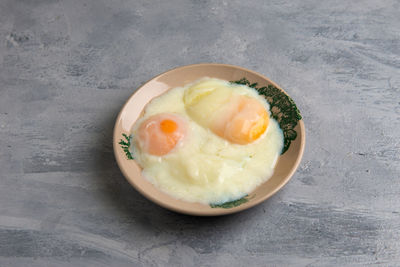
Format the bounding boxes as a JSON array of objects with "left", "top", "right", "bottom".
[{"left": 183, "top": 80, "right": 269, "bottom": 145}]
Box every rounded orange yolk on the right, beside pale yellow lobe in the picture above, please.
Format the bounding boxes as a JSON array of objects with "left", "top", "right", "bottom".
[{"left": 211, "top": 96, "right": 269, "bottom": 145}]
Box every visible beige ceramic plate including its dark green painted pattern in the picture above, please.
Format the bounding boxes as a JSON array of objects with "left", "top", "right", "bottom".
[{"left": 113, "top": 64, "right": 305, "bottom": 216}]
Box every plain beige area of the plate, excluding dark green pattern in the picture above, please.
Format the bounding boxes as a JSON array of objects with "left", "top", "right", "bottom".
[{"left": 113, "top": 64, "right": 305, "bottom": 216}]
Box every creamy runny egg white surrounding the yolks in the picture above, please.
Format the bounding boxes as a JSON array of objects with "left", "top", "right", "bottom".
[{"left": 132, "top": 78, "right": 283, "bottom": 204}]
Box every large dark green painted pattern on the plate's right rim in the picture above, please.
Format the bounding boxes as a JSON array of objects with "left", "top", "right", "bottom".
[{"left": 231, "top": 78, "right": 301, "bottom": 154}]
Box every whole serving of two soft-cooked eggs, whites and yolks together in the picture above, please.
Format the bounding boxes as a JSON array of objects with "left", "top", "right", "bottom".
[{"left": 130, "top": 78, "right": 283, "bottom": 204}]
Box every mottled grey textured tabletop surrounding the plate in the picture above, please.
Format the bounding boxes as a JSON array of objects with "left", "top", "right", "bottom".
[{"left": 0, "top": 0, "right": 400, "bottom": 266}]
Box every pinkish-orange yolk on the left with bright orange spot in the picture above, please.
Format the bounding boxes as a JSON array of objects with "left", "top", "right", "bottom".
[{"left": 138, "top": 114, "right": 186, "bottom": 156}]
